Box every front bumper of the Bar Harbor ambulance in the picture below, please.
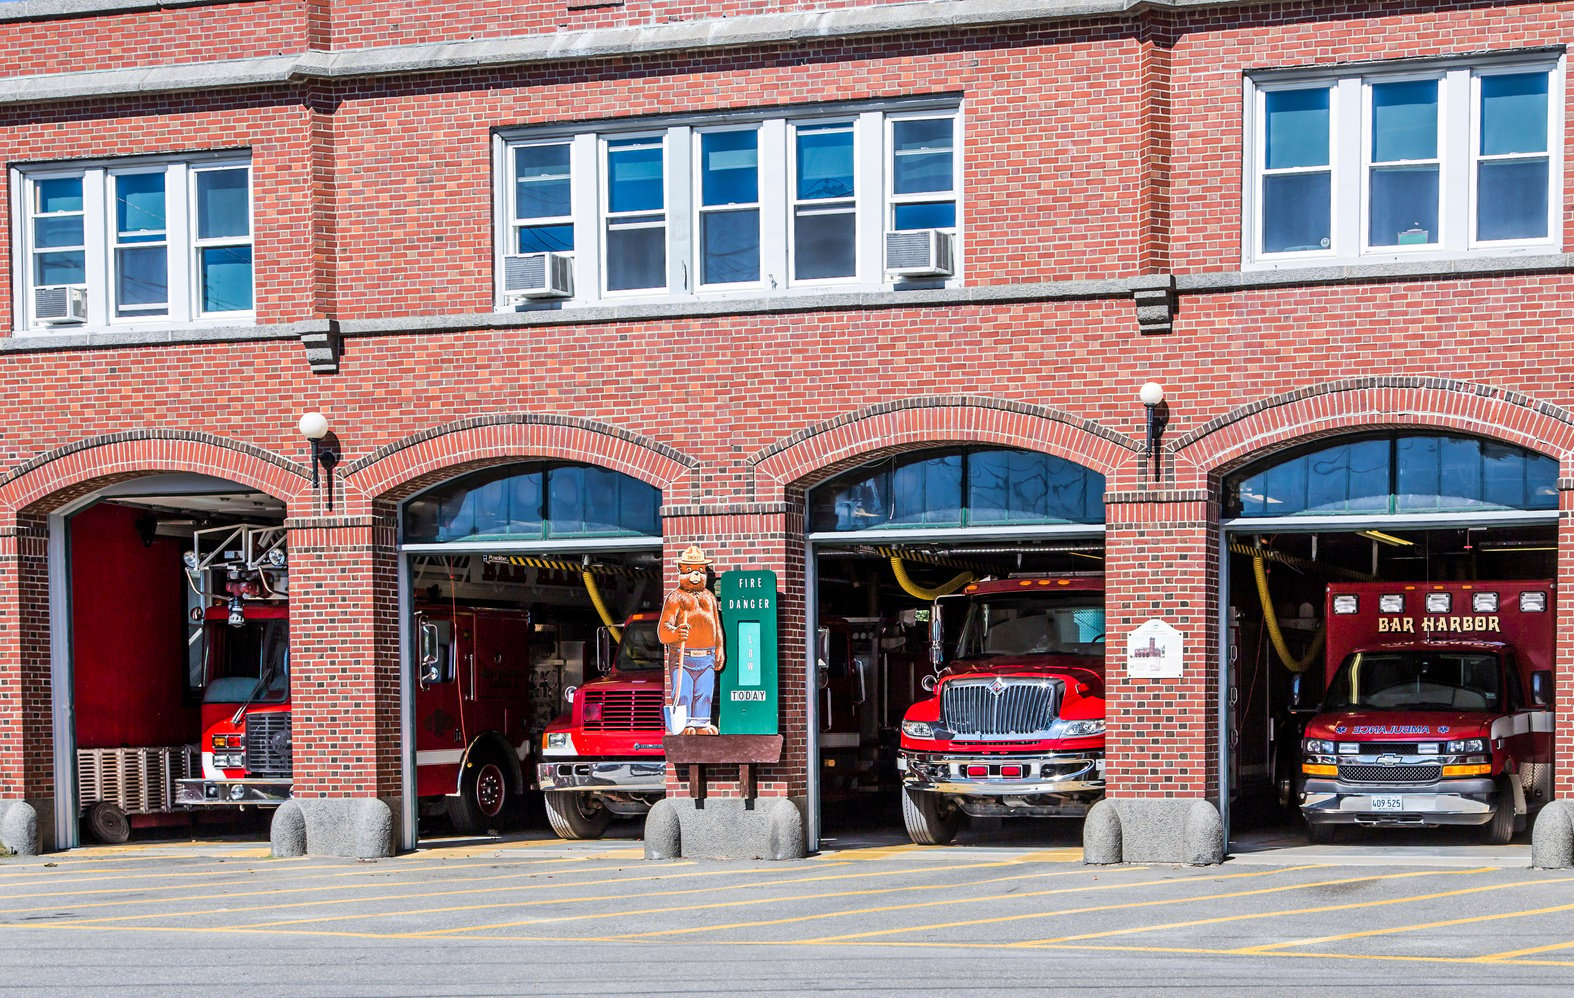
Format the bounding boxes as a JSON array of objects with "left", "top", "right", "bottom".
[{"left": 1300, "top": 779, "right": 1513, "bottom": 828}]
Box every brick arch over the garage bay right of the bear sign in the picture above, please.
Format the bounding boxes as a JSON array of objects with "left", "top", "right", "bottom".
[{"left": 748, "top": 395, "right": 1141, "bottom": 501}]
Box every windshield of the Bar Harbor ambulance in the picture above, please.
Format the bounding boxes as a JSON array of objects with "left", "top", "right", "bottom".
[{"left": 1324, "top": 649, "right": 1498, "bottom": 710}]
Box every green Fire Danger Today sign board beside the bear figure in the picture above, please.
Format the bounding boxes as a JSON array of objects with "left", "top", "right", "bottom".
[{"left": 716, "top": 571, "right": 778, "bottom": 735}]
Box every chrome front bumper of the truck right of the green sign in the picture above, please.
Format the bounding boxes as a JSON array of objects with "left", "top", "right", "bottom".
[{"left": 897, "top": 751, "right": 1103, "bottom": 817}]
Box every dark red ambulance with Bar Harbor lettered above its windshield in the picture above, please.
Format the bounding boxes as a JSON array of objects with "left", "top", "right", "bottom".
[{"left": 1291, "top": 581, "right": 1554, "bottom": 844}]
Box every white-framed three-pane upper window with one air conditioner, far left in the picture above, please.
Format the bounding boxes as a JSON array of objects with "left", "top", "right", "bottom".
[{"left": 13, "top": 154, "right": 253, "bottom": 332}]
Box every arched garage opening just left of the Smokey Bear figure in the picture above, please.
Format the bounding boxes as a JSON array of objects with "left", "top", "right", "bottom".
[{"left": 400, "top": 461, "right": 664, "bottom": 839}]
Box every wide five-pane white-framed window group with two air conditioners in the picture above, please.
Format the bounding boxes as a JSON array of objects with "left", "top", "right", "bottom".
[{"left": 496, "top": 102, "right": 962, "bottom": 309}]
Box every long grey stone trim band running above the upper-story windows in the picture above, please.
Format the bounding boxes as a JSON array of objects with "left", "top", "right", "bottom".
[{"left": 9, "top": 0, "right": 1315, "bottom": 104}]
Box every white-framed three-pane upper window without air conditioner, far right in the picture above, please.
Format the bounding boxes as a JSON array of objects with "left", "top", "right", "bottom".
[{"left": 1243, "top": 55, "right": 1563, "bottom": 266}]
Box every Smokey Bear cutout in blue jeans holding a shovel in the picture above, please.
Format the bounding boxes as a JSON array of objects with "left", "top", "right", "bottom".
[{"left": 656, "top": 545, "right": 727, "bottom": 735}]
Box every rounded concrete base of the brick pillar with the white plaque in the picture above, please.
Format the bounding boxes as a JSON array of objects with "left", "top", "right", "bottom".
[{"left": 1083, "top": 798, "right": 1225, "bottom": 866}]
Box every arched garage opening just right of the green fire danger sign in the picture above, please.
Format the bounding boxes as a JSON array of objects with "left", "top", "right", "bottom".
[{"left": 807, "top": 445, "right": 1105, "bottom": 847}]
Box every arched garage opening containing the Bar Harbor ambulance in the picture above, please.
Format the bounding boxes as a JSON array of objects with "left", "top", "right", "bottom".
[{"left": 1221, "top": 430, "right": 1558, "bottom": 850}]
